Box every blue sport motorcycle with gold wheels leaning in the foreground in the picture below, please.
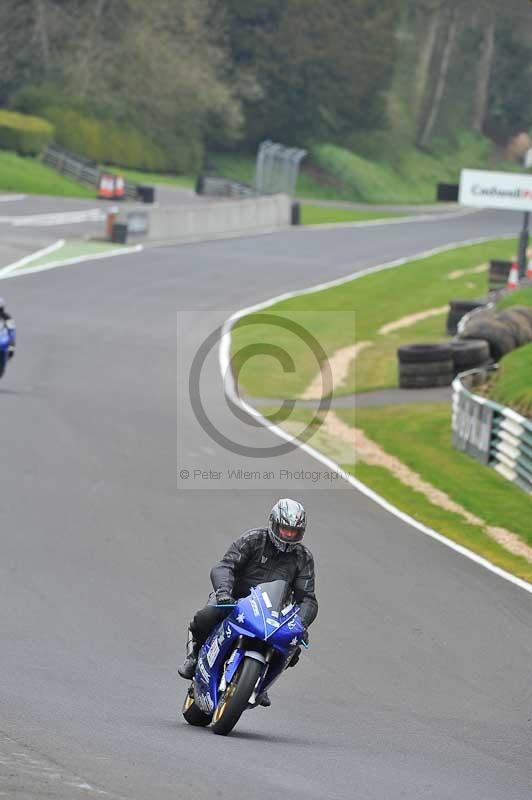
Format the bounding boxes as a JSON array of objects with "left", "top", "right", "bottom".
[{"left": 183, "top": 580, "right": 305, "bottom": 736}]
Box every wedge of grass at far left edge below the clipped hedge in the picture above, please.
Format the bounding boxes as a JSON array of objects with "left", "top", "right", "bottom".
[{"left": 0, "top": 150, "right": 96, "bottom": 199}]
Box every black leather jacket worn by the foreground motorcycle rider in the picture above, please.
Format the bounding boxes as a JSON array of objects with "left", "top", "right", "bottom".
[{"left": 211, "top": 528, "right": 318, "bottom": 628}]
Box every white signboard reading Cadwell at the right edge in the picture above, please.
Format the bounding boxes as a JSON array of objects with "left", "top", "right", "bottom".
[{"left": 458, "top": 169, "right": 532, "bottom": 211}]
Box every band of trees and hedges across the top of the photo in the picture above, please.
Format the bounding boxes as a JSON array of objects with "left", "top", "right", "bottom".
[{"left": 0, "top": 0, "right": 532, "bottom": 173}]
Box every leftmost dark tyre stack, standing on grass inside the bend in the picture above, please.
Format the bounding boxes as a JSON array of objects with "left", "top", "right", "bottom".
[{"left": 397, "top": 343, "right": 454, "bottom": 389}]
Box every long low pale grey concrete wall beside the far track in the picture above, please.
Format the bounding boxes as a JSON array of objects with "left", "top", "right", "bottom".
[{"left": 130, "top": 194, "right": 292, "bottom": 242}]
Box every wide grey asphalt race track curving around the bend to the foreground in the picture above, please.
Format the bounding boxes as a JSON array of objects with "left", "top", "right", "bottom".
[{"left": 0, "top": 212, "right": 532, "bottom": 800}]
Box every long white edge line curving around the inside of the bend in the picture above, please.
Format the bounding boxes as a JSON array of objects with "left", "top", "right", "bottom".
[{"left": 218, "top": 234, "right": 532, "bottom": 594}]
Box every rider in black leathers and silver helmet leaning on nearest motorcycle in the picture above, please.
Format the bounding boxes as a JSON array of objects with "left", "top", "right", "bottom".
[{"left": 178, "top": 498, "right": 318, "bottom": 706}]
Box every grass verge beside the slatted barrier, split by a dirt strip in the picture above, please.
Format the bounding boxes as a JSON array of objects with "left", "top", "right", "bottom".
[{"left": 261, "top": 403, "right": 532, "bottom": 581}]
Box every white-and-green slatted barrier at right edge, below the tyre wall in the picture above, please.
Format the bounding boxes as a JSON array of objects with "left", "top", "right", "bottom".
[{"left": 452, "top": 369, "right": 532, "bottom": 494}]
